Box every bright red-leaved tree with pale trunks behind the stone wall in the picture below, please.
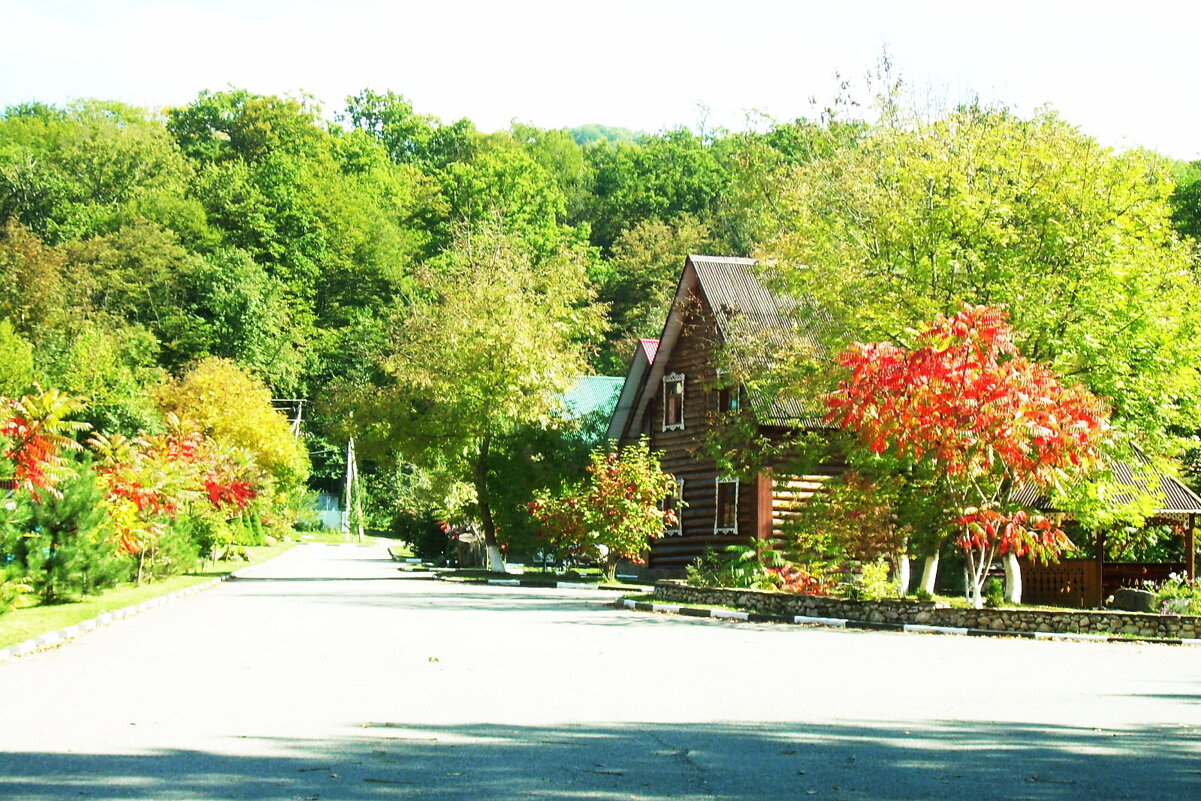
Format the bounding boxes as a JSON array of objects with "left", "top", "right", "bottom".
[{"left": 826, "top": 306, "right": 1107, "bottom": 606}]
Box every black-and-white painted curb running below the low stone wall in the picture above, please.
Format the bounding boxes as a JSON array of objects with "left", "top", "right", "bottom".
[{"left": 614, "top": 598, "right": 1201, "bottom": 647}]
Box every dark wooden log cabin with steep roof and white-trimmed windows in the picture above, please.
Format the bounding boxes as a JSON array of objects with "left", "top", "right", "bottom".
[{"left": 608, "top": 256, "right": 844, "bottom": 575}]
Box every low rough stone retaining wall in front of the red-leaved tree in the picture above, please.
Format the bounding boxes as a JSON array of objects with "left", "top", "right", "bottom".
[{"left": 655, "top": 580, "right": 1201, "bottom": 639}]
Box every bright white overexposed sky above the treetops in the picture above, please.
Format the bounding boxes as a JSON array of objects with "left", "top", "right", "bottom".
[{"left": 0, "top": 0, "right": 1201, "bottom": 160}]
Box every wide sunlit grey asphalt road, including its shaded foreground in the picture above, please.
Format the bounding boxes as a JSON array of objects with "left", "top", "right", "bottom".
[{"left": 0, "top": 545, "right": 1201, "bottom": 801}]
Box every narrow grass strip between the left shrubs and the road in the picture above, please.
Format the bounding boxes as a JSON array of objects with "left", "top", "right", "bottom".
[{"left": 0, "top": 542, "right": 295, "bottom": 648}]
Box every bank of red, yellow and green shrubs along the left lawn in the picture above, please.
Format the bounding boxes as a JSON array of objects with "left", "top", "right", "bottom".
[{"left": 0, "top": 365, "right": 306, "bottom": 612}]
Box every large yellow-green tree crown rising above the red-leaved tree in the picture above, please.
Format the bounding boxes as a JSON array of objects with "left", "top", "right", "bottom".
[{"left": 763, "top": 107, "right": 1201, "bottom": 446}]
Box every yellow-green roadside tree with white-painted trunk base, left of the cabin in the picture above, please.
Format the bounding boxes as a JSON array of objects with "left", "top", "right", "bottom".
[{"left": 386, "top": 228, "right": 599, "bottom": 570}]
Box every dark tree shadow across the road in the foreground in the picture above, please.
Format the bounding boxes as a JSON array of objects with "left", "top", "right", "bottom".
[{"left": 0, "top": 721, "right": 1201, "bottom": 801}]
